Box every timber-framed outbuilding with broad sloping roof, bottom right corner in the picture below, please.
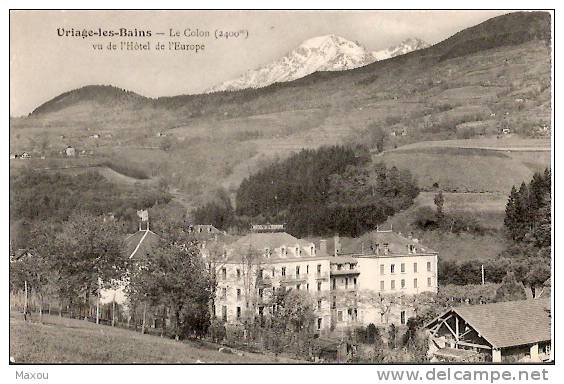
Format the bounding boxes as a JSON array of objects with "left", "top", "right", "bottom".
[{"left": 425, "top": 298, "right": 552, "bottom": 363}]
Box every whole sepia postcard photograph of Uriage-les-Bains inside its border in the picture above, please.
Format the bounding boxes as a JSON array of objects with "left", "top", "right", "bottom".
[{"left": 5, "top": 9, "right": 555, "bottom": 372}]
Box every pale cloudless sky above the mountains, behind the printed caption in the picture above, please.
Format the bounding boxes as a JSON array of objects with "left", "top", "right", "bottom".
[{"left": 10, "top": 11, "right": 505, "bottom": 116}]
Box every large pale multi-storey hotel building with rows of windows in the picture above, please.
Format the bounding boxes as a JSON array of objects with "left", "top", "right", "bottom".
[{"left": 208, "top": 226, "right": 437, "bottom": 332}]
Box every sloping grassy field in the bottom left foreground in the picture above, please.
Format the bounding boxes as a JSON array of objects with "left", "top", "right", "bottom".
[{"left": 10, "top": 313, "right": 297, "bottom": 364}]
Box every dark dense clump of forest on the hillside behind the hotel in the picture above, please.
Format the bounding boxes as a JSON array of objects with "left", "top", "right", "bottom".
[{"left": 194, "top": 146, "right": 419, "bottom": 237}]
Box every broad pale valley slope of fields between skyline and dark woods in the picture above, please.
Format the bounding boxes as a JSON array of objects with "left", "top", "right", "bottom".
[{"left": 10, "top": 12, "right": 552, "bottom": 218}]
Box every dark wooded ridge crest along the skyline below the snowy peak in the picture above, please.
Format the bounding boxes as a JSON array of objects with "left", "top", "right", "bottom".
[{"left": 26, "top": 11, "right": 551, "bottom": 117}]
